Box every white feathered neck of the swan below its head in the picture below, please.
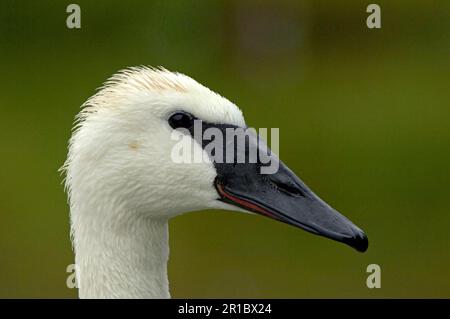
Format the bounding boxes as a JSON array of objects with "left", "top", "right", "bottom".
[{"left": 71, "top": 212, "right": 170, "bottom": 298}]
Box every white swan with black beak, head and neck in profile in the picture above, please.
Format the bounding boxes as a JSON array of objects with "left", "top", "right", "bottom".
[{"left": 62, "top": 66, "right": 368, "bottom": 298}]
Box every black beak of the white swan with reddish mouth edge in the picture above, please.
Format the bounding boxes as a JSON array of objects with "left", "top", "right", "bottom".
[{"left": 191, "top": 124, "right": 368, "bottom": 252}]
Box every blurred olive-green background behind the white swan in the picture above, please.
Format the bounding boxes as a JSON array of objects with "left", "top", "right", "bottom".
[{"left": 0, "top": 0, "right": 450, "bottom": 298}]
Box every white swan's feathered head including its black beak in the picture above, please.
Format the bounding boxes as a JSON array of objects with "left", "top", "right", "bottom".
[{"left": 64, "top": 67, "right": 368, "bottom": 251}]
